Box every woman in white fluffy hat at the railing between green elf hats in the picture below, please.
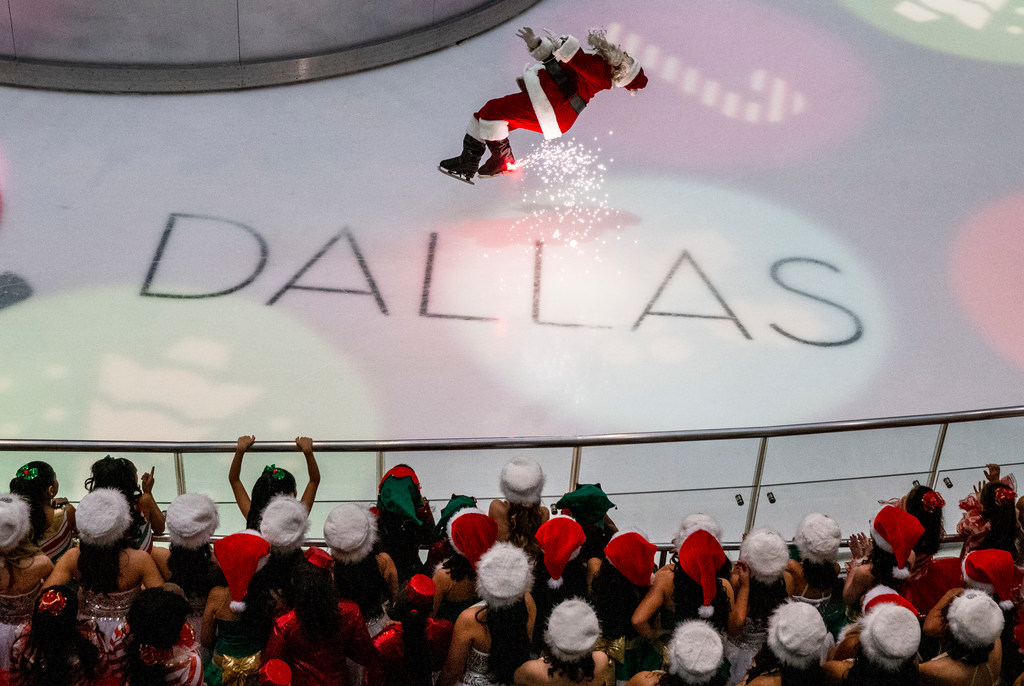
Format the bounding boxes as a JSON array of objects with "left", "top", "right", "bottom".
[{"left": 487, "top": 455, "right": 551, "bottom": 560}]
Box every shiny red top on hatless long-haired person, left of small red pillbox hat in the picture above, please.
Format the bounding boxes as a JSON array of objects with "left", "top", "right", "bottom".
[{"left": 262, "top": 600, "right": 381, "bottom": 686}]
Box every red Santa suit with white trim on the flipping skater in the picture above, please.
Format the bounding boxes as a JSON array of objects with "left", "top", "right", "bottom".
[{"left": 469, "top": 36, "right": 647, "bottom": 140}]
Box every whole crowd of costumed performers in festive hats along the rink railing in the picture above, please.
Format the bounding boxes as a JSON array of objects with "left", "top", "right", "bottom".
[{"left": 0, "top": 436, "right": 1024, "bottom": 686}]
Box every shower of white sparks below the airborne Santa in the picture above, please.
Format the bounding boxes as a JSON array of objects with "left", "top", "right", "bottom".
[{"left": 511, "top": 138, "right": 621, "bottom": 256}]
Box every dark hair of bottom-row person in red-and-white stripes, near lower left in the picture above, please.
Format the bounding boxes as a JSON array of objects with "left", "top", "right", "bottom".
[{"left": 125, "top": 589, "right": 188, "bottom": 684}]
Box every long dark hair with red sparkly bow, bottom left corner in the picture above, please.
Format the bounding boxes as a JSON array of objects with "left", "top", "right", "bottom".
[{"left": 26, "top": 586, "right": 99, "bottom": 686}]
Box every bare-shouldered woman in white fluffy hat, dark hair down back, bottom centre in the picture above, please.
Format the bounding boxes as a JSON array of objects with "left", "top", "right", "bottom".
[{"left": 437, "top": 543, "right": 537, "bottom": 686}]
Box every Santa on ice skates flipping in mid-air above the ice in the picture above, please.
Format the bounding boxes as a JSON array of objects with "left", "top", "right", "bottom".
[{"left": 437, "top": 27, "right": 647, "bottom": 183}]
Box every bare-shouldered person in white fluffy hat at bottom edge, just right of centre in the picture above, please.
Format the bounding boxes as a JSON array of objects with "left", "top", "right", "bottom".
[{"left": 515, "top": 598, "right": 608, "bottom": 686}]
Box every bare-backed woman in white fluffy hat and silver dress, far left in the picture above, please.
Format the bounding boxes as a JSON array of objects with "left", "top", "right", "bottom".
[{"left": 45, "top": 488, "right": 164, "bottom": 677}]
